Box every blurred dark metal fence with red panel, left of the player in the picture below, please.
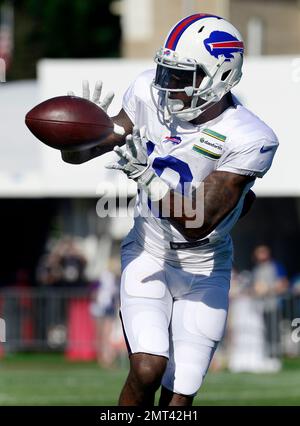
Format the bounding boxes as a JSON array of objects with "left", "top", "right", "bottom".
[{"left": 0, "top": 288, "right": 124, "bottom": 360}]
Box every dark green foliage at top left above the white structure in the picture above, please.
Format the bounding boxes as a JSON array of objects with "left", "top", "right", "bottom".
[{"left": 5, "top": 0, "right": 121, "bottom": 78}]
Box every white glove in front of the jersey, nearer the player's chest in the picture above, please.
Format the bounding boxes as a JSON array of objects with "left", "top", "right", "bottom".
[{"left": 105, "top": 127, "right": 169, "bottom": 201}]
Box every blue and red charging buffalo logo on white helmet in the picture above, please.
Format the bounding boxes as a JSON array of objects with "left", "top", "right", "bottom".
[{"left": 204, "top": 31, "right": 244, "bottom": 61}]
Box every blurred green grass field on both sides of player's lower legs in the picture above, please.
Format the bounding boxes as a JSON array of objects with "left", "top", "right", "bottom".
[{"left": 0, "top": 354, "right": 300, "bottom": 406}]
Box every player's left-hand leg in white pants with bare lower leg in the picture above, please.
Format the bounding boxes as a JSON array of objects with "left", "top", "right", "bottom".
[{"left": 119, "top": 243, "right": 172, "bottom": 406}]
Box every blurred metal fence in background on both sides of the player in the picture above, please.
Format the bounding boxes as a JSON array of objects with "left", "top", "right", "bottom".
[{"left": 0, "top": 288, "right": 300, "bottom": 358}]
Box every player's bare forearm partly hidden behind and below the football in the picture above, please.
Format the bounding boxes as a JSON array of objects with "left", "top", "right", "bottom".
[{"left": 61, "top": 109, "right": 133, "bottom": 164}]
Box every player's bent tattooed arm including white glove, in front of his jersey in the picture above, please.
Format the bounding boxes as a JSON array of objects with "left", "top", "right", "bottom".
[{"left": 107, "top": 128, "right": 255, "bottom": 241}]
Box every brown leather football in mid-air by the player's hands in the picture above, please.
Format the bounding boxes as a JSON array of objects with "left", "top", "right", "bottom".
[{"left": 25, "top": 96, "right": 113, "bottom": 151}]
